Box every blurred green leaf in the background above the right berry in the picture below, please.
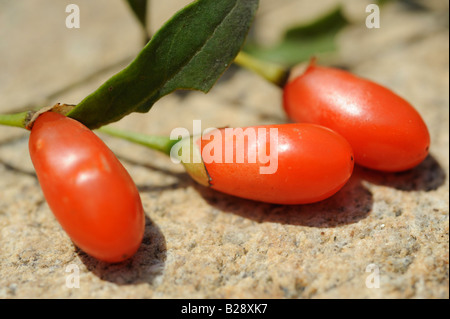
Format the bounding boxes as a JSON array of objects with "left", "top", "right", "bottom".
[{"left": 244, "top": 7, "right": 348, "bottom": 67}]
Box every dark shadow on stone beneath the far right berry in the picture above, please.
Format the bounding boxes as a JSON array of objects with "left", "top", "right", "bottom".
[{"left": 361, "top": 155, "right": 447, "bottom": 192}]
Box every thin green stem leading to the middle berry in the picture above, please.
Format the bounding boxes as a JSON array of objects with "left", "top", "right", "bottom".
[{"left": 98, "top": 126, "right": 180, "bottom": 156}]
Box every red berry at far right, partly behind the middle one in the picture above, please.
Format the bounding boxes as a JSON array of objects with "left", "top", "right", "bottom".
[{"left": 283, "top": 64, "right": 430, "bottom": 172}]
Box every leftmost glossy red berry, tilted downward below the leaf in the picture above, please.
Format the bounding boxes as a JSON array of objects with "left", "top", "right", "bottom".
[{"left": 29, "top": 112, "right": 145, "bottom": 262}]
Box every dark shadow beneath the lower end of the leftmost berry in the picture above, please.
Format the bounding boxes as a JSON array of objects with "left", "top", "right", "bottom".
[{"left": 77, "top": 216, "right": 167, "bottom": 285}]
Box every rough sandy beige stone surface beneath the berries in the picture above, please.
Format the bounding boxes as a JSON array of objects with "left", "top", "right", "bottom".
[{"left": 0, "top": 0, "right": 449, "bottom": 298}]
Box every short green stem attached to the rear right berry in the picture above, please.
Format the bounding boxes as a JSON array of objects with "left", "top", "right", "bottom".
[{"left": 234, "top": 51, "right": 289, "bottom": 88}]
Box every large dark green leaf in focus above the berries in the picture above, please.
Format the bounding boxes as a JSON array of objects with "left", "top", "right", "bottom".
[{"left": 67, "top": 0, "right": 258, "bottom": 128}]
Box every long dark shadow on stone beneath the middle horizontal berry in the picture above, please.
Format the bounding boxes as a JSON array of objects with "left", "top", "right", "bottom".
[{"left": 196, "top": 171, "right": 373, "bottom": 228}]
